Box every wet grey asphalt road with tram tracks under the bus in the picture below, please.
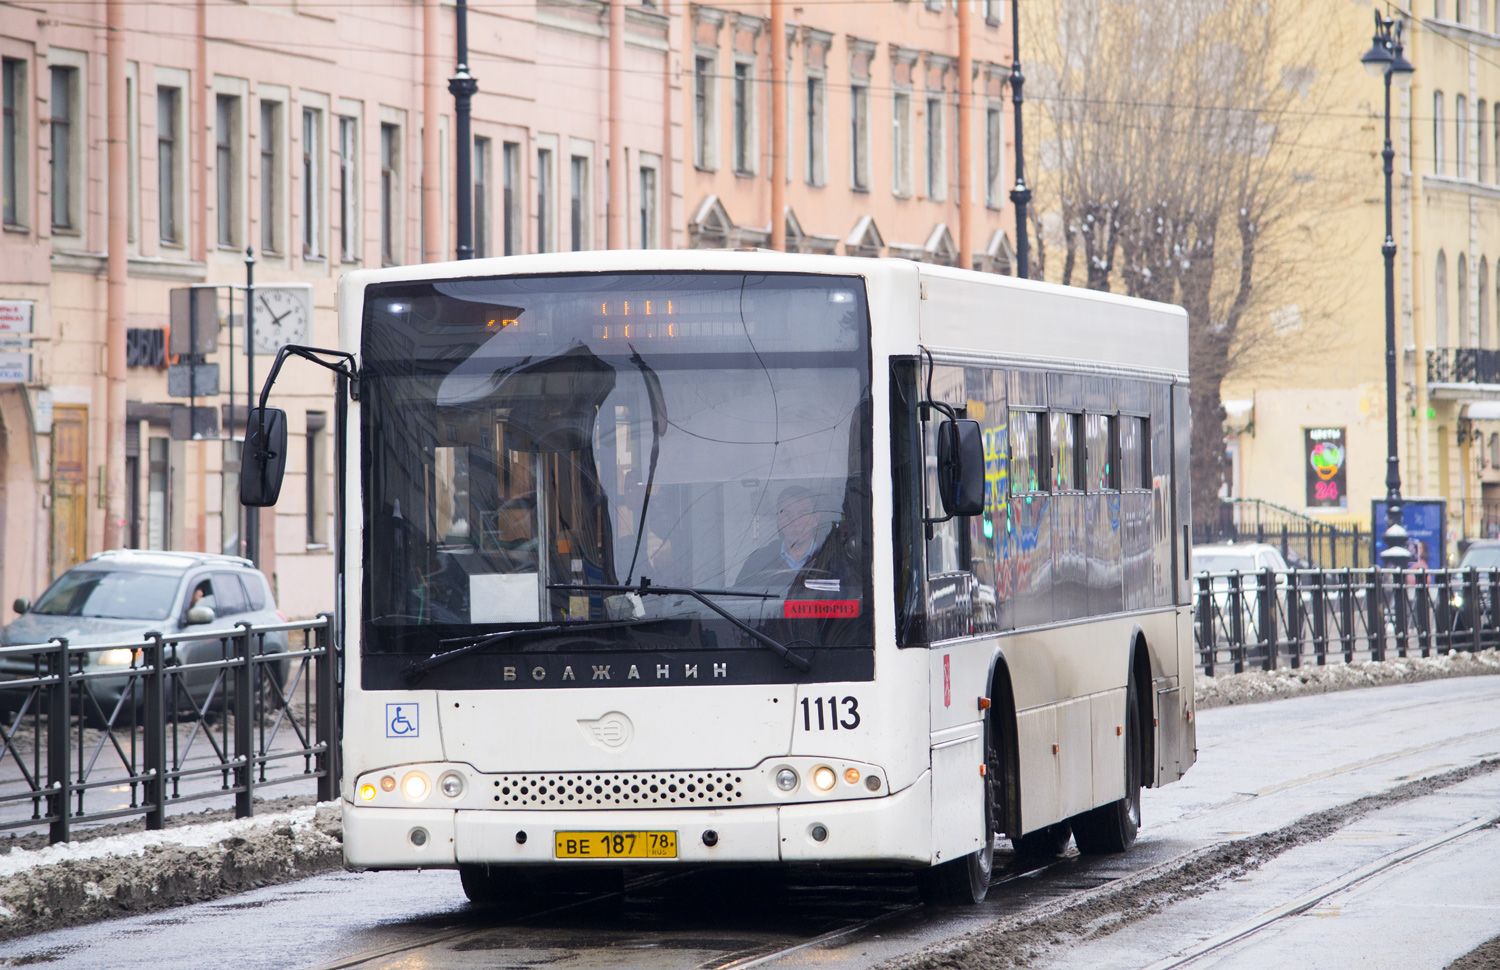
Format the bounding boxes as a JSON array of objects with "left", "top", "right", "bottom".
[{"left": 0, "top": 678, "right": 1500, "bottom": 970}]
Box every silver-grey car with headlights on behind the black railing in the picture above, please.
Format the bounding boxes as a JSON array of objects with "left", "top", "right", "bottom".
[{"left": 0, "top": 549, "right": 287, "bottom": 721}]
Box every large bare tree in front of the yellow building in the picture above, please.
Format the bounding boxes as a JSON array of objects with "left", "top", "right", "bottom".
[{"left": 1032, "top": 0, "right": 1352, "bottom": 517}]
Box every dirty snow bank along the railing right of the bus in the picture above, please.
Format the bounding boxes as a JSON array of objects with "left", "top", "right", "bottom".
[{"left": 1193, "top": 649, "right": 1500, "bottom": 711}]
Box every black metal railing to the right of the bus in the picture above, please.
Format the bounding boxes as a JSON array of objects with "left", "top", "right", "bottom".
[{"left": 1193, "top": 568, "right": 1500, "bottom": 676}]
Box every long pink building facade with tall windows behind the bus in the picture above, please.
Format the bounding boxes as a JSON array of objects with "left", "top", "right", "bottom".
[{"left": 0, "top": 0, "right": 1011, "bottom": 616}]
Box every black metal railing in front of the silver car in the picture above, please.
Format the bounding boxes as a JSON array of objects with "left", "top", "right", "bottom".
[{"left": 0, "top": 613, "right": 339, "bottom": 843}]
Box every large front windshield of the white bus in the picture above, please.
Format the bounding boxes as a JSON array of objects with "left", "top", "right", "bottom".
[{"left": 360, "top": 273, "right": 873, "bottom": 654}]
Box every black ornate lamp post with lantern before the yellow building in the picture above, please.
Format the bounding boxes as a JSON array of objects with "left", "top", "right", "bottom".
[{"left": 1359, "top": 10, "right": 1413, "bottom": 570}]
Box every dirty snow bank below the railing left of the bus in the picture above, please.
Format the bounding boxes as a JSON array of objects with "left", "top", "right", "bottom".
[{"left": 0, "top": 802, "right": 344, "bottom": 939}]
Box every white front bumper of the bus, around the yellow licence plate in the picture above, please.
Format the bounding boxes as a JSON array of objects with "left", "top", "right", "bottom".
[{"left": 344, "top": 772, "right": 932, "bottom": 870}]
